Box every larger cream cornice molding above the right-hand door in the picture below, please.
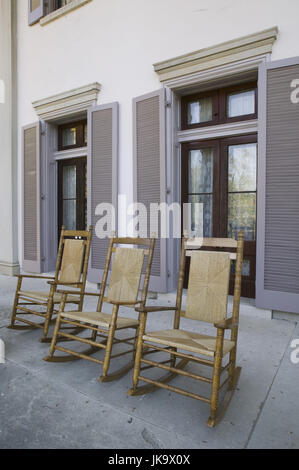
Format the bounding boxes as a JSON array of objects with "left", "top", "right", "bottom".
[{"left": 154, "top": 27, "right": 278, "bottom": 82}]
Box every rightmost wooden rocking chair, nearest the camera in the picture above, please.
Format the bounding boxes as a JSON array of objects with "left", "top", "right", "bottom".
[{"left": 128, "top": 232, "right": 244, "bottom": 427}]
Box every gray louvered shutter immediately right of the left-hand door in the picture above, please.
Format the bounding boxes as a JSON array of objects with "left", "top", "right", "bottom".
[{"left": 87, "top": 103, "right": 118, "bottom": 283}]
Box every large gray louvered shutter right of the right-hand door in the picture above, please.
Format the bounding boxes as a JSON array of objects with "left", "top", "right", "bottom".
[{"left": 256, "top": 57, "right": 299, "bottom": 313}]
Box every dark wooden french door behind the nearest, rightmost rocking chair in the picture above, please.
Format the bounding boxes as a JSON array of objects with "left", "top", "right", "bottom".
[{"left": 181, "top": 135, "right": 257, "bottom": 298}]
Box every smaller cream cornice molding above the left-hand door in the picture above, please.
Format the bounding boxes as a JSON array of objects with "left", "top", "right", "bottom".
[{"left": 32, "top": 82, "right": 101, "bottom": 121}]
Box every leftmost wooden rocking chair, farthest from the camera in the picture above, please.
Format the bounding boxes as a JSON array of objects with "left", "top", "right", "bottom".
[{"left": 8, "top": 226, "right": 92, "bottom": 342}]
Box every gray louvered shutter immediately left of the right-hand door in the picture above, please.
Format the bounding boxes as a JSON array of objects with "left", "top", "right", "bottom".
[{"left": 133, "top": 88, "right": 167, "bottom": 292}]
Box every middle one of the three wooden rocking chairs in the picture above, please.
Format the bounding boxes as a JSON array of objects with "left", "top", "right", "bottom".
[{"left": 44, "top": 236, "right": 155, "bottom": 382}]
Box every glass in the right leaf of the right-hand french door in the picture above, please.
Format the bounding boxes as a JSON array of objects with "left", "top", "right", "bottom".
[{"left": 227, "top": 144, "right": 257, "bottom": 241}]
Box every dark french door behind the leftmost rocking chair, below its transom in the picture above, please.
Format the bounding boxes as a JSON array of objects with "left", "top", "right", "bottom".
[{"left": 58, "top": 157, "right": 87, "bottom": 239}]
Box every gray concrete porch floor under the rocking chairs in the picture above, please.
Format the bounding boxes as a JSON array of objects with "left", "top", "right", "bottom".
[{"left": 0, "top": 276, "right": 299, "bottom": 449}]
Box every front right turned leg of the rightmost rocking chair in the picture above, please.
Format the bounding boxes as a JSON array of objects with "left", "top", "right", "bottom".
[{"left": 207, "top": 328, "right": 224, "bottom": 427}]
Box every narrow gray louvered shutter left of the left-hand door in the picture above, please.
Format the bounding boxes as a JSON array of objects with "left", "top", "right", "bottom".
[{"left": 22, "top": 123, "right": 41, "bottom": 273}]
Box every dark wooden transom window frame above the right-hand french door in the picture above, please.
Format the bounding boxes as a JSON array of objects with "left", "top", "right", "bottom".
[{"left": 181, "top": 81, "right": 258, "bottom": 130}]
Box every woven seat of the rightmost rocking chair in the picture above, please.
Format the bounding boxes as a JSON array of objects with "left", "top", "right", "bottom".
[{"left": 143, "top": 329, "right": 235, "bottom": 357}]
